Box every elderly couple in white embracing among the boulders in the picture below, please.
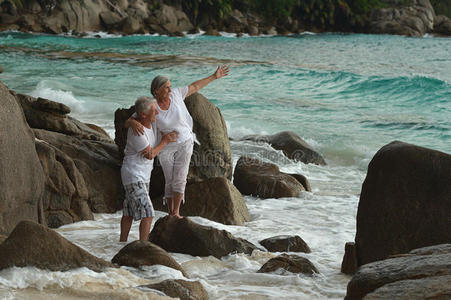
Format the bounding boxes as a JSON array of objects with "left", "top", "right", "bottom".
[{"left": 120, "top": 66, "right": 229, "bottom": 242}]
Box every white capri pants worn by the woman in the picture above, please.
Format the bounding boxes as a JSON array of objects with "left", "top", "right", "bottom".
[{"left": 158, "top": 139, "right": 194, "bottom": 202}]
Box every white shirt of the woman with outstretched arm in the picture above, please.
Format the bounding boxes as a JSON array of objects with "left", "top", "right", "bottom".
[{"left": 156, "top": 86, "right": 195, "bottom": 148}]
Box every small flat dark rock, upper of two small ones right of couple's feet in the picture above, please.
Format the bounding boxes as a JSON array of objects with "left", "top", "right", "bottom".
[{"left": 259, "top": 235, "right": 312, "bottom": 253}]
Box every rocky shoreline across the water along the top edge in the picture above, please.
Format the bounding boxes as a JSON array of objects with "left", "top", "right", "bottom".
[{"left": 0, "top": 0, "right": 451, "bottom": 37}]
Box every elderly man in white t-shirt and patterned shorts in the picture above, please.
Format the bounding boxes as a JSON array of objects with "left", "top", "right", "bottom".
[{"left": 120, "top": 96, "right": 178, "bottom": 242}]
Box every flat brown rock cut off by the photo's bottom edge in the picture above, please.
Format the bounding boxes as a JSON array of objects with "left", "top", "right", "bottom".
[{"left": 144, "top": 279, "right": 208, "bottom": 300}]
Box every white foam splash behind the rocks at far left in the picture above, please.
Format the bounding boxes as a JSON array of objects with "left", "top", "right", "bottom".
[{"left": 30, "top": 80, "right": 85, "bottom": 113}]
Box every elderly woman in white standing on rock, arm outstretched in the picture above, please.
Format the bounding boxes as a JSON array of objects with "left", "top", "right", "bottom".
[{"left": 126, "top": 66, "right": 229, "bottom": 218}]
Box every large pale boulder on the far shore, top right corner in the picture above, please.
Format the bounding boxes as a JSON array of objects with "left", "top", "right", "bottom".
[{"left": 369, "top": 0, "right": 435, "bottom": 36}]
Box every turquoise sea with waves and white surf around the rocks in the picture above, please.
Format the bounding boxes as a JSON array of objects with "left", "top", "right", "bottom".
[{"left": 0, "top": 32, "right": 451, "bottom": 299}]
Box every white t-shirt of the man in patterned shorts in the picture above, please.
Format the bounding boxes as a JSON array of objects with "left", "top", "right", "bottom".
[{"left": 121, "top": 123, "right": 158, "bottom": 185}]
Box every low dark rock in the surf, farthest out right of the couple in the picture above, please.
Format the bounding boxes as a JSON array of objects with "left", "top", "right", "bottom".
[{"left": 241, "top": 131, "right": 326, "bottom": 166}]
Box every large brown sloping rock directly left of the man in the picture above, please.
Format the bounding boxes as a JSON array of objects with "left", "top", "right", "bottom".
[{"left": 33, "top": 129, "right": 124, "bottom": 217}]
